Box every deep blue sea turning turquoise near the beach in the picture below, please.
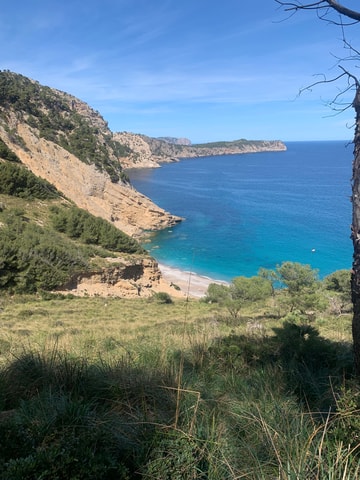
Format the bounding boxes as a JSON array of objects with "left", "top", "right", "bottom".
[{"left": 129, "top": 141, "right": 353, "bottom": 280}]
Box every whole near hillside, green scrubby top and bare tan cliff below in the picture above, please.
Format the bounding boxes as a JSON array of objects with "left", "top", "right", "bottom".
[{"left": 0, "top": 71, "right": 180, "bottom": 235}]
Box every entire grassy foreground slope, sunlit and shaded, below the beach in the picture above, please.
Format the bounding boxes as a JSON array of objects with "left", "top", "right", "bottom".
[{"left": 0, "top": 266, "right": 360, "bottom": 480}]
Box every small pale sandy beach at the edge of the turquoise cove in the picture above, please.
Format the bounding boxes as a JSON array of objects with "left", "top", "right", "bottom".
[{"left": 159, "top": 263, "right": 227, "bottom": 298}]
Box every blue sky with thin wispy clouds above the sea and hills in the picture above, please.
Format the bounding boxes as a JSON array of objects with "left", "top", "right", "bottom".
[{"left": 0, "top": 0, "right": 360, "bottom": 143}]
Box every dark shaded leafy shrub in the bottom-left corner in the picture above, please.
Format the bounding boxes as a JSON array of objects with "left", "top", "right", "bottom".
[{"left": 0, "top": 394, "right": 129, "bottom": 480}]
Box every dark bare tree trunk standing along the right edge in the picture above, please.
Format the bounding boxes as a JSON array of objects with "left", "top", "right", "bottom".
[{"left": 351, "top": 87, "right": 360, "bottom": 376}]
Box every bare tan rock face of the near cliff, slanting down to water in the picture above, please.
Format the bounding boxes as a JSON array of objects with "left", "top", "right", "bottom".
[{"left": 0, "top": 123, "right": 180, "bottom": 235}]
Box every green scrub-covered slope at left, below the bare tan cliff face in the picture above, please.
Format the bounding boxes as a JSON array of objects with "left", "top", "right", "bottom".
[{"left": 0, "top": 199, "right": 144, "bottom": 293}]
